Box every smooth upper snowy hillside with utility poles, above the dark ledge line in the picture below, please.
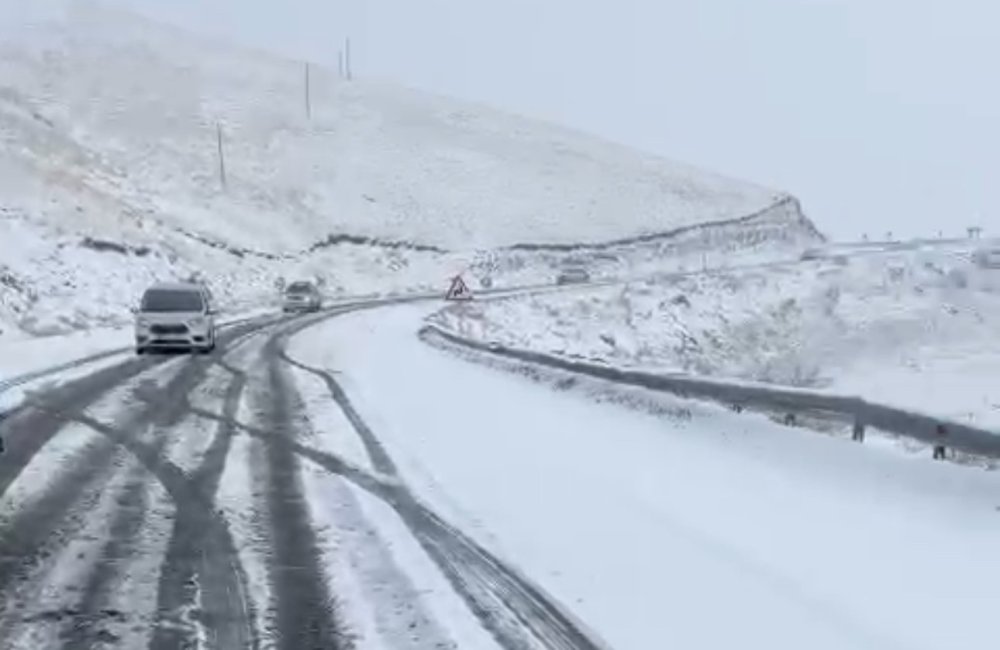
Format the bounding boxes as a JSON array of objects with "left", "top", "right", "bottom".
[{"left": 0, "top": 0, "right": 812, "bottom": 250}]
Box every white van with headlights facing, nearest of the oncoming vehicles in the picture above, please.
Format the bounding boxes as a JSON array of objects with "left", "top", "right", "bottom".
[{"left": 135, "top": 282, "right": 216, "bottom": 354}]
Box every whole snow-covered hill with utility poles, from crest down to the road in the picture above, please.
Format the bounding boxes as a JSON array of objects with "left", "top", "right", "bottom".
[{"left": 0, "top": 0, "right": 821, "bottom": 332}]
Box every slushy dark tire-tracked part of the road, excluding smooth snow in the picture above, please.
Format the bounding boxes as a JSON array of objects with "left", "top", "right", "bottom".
[{"left": 0, "top": 306, "right": 599, "bottom": 650}]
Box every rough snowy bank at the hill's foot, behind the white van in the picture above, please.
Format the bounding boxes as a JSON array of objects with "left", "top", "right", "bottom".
[{"left": 0, "top": 205, "right": 456, "bottom": 340}]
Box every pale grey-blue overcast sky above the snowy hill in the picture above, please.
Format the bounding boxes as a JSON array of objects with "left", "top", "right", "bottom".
[{"left": 116, "top": 0, "right": 1000, "bottom": 238}]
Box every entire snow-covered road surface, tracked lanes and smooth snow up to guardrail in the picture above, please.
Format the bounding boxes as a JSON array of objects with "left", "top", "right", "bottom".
[{"left": 0, "top": 305, "right": 1000, "bottom": 650}]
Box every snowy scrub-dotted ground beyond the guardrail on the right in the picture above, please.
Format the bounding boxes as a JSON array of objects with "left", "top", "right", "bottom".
[{"left": 431, "top": 245, "right": 1000, "bottom": 428}]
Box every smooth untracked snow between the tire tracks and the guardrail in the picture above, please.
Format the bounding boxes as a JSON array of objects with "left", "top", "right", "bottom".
[{"left": 292, "top": 306, "right": 1000, "bottom": 650}]
